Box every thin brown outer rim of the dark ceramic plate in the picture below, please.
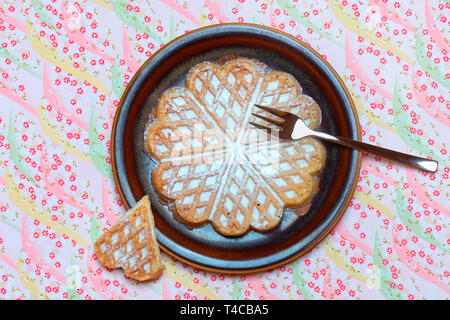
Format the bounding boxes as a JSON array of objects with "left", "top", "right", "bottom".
[{"left": 110, "top": 22, "right": 362, "bottom": 275}]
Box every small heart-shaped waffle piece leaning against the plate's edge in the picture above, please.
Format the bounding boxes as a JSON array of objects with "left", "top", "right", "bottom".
[{"left": 94, "top": 196, "right": 164, "bottom": 281}]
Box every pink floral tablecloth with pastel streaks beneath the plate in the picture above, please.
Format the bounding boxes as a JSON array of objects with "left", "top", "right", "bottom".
[{"left": 0, "top": 0, "right": 450, "bottom": 300}]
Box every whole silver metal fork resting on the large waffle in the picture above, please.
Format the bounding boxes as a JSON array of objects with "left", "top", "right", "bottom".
[{"left": 249, "top": 104, "right": 438, "bottom": 172}]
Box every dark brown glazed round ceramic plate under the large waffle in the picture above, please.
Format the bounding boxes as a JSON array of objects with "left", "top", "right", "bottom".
[{"left": 112, "top": 24, "right": 361, "bottom": 273}]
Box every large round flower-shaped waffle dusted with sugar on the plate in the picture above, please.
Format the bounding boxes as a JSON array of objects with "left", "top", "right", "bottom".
[{"left": 145, "top": 57, "right": 326, "bottom": 236}]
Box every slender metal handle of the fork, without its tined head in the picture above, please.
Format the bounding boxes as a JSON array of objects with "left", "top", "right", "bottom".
[{"left": 314, "top": 132, "right": 438, "bottom": 172}]
